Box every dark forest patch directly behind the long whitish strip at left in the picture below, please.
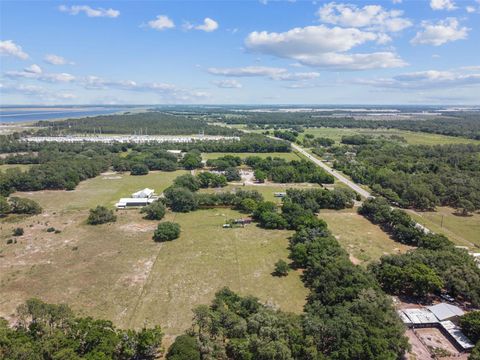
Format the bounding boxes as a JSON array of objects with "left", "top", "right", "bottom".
[{"left": 35, "top": 111, "right": 241, "bottom": 135}]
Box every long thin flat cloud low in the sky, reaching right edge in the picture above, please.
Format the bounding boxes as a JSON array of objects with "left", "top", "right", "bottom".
[{"left": 355, "top": 69, "right": 480, "bottom": 89}]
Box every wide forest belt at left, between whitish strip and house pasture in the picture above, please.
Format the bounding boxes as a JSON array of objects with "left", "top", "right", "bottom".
[{"left": 0, "top": 135, "right": 291, "bottom": 196}]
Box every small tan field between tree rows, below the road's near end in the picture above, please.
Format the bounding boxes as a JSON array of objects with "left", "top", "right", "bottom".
[{"left": 319, "top": 208, "right": 411, "bottom": 263}]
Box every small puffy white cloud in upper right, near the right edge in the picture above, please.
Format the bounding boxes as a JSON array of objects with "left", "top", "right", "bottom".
[{"left": 410, "top": 18, "right": 470, "bottom": 46}]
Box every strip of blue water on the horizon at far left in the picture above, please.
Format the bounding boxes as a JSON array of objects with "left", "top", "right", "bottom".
[{"left": 0, "top": 107, "right": 129, "bottom": 123}]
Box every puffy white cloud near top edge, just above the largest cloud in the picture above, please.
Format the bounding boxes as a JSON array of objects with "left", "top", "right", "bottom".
[{"left": 317, "top": 2, "right": 412, "bottom": 32}]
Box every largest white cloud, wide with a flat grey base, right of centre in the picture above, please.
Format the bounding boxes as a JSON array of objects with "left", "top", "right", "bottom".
[{"left": 245, "top": 25, "right": 406, "bottom": 70}]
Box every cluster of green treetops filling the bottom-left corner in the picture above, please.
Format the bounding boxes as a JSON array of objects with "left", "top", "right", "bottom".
[{"left": 0, "top": 299, "right": 163, "bottom": 360}]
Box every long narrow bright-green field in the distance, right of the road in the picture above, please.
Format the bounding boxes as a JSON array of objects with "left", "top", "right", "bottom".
[{"left": 300, "top": 128, "right": 480, "bottom": 145}]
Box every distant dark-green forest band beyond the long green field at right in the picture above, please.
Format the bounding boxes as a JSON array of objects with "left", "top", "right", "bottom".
[{"left": 222, "top": 112, "right": 480, "bottom": 140}]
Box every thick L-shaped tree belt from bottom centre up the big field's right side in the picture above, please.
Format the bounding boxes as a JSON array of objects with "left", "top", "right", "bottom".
[{"left": 167, "top": 190, "right": 408, "bottom": 360}]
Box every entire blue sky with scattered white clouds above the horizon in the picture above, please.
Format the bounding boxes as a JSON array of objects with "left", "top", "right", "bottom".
[{"left": 0, "top": 0, "right": 480, "bottom": 105}]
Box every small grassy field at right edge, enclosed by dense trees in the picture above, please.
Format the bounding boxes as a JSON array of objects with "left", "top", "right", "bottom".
[{"left": 409, "top": 206, "right": 480, "bottom": 252}]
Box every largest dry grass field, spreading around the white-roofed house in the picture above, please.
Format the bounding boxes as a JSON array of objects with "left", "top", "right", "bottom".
[{"left": 0, "top": 172, "right": 307, "bottom": 335}]
